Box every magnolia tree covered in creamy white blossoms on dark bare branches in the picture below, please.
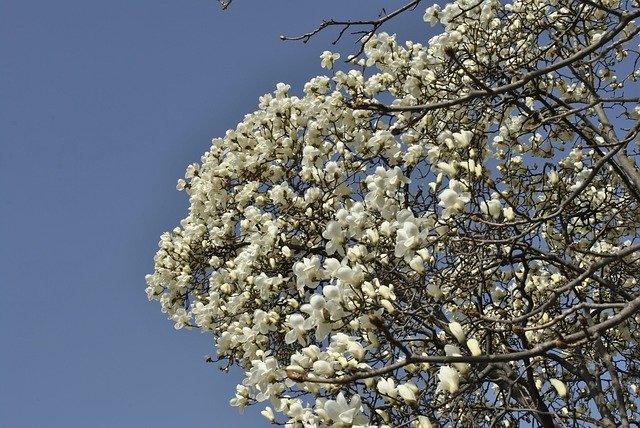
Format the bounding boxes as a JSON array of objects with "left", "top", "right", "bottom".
[{"left": 146, "top": 0, "right": 640, "bottom": 428}]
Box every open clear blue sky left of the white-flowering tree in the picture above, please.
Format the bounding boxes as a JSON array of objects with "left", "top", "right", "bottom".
[{"left": 0, "top": 0, "right": 426, "bottom": 428}]
